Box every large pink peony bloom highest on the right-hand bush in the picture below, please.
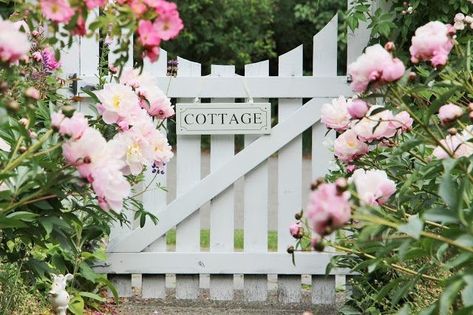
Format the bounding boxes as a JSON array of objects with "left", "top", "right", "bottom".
[{"left": 409, "top": 21, "right": 454, "bottom": 67}]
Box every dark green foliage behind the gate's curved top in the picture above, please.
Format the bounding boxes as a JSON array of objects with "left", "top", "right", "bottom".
[{"left": 163, "top": 0, "right": 346, "bottom": 74}]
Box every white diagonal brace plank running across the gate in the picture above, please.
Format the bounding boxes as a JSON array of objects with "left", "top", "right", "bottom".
[{"left": 108, "top": 97, "right": 320, "bottom": 252}]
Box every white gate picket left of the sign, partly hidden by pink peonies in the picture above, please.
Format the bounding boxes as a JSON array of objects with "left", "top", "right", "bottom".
[{"left": 141, "top": 49, "right": 172, "bottom": 299}]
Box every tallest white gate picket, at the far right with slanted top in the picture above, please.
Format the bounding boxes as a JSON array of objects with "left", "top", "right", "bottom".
[{"left": 312, "top": 15, "right": 338, "bottom": 305}]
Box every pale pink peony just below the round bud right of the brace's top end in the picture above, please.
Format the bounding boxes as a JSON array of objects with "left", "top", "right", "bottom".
[{"left": 334, "top": 130, "right": 369, "bottom": 163}]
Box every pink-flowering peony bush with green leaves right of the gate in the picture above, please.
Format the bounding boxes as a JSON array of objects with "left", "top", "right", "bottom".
[{"left": 290, "top": 8, "right": 473, "bottom": 314}]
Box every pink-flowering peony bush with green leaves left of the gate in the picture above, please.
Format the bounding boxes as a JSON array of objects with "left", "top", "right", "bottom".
[{"left": 0, "top": 0, "right": 183, "bottom": 314}]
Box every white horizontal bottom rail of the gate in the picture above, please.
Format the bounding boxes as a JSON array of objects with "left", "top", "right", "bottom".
[{"left": 95, "top": 252, "right": 350, "bottom": 275}]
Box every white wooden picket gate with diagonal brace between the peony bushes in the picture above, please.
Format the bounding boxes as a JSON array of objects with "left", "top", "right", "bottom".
[{"left": 62, "top": 3, "right": 374, "bottom": 304}]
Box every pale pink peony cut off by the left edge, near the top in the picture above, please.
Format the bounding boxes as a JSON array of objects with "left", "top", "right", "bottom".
[{"left": 0, "top": 18, "right": 31, "bottom": 63}]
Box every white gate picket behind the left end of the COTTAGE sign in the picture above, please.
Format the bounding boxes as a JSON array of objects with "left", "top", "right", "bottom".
[{"left": 175, "top": 58, "right": 201, "bottom": 299}]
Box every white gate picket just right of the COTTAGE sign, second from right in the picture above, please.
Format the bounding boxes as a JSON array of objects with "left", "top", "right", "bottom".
[{"left": 278, "top": 45, "right": 303, "bottom": 303}]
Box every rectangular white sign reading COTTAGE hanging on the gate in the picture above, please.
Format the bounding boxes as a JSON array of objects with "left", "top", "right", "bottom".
[{"left": 176, "top": 103, "right": 271, "bottom": 135}]
